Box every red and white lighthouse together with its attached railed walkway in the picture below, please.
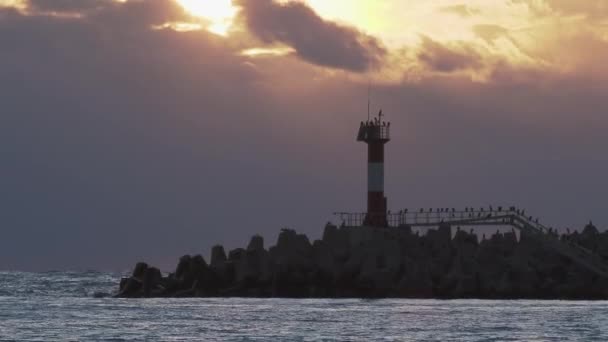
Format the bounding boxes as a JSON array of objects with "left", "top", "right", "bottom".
[{"left": 335, "top": 117, "right": 608, "bottom": 277}]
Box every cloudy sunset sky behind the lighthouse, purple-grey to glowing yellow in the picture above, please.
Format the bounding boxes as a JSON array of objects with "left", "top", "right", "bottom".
[{"left": 0, "top": 0, "right": 608, "bottom": 271}]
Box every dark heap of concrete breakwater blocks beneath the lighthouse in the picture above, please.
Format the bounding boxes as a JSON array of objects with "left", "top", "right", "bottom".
[{"left": 117, "top": 224, "right": 608, "bottom": 299}]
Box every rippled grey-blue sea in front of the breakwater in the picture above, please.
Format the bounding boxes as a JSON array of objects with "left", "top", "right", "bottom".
[{"left": 0, "top": 272, "right": 608, "bottom": 341}]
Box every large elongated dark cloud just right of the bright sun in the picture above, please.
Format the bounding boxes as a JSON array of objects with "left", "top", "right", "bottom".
[{"left": 238, "top": 0, "right": 386, "bottom": 71}]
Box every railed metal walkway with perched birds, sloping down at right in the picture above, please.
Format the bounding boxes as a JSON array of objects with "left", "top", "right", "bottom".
[{"left": 335, "top": 207, "right": 608, "bottom": 278}]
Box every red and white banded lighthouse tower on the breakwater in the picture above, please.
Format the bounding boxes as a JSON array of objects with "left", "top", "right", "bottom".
[{"left": 357, "top": 111, "right": 391, "bottom": 227}]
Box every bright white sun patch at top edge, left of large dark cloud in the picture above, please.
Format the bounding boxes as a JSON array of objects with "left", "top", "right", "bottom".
[{"left": 177, "top": 0, "right": 237, "bottom": 36}]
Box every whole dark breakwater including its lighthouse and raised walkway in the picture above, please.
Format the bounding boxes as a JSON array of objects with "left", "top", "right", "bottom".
[{"left": 117, "top": 118, "right": 608, "bottom": 300}]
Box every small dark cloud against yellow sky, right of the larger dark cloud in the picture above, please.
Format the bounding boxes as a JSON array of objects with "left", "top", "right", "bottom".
[{"left": 418, "top": 36, "right": 482, "bottom": 73}]
